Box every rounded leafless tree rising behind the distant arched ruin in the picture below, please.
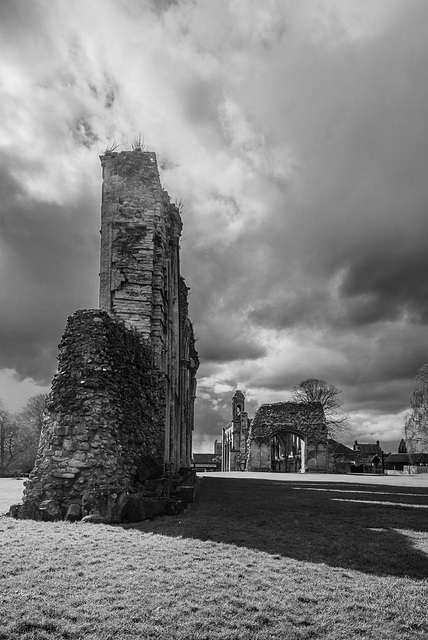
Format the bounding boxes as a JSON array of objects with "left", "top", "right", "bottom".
[{"left": 293, "top": 378, "right": 349, "bottom": 437}]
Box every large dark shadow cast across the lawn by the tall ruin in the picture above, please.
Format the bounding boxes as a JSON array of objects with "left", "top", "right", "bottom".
[{"left": 127, "top": 477, "right": 428, "bottom": 579}]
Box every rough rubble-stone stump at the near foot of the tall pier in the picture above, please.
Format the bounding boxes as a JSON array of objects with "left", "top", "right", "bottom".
[{"left": 19, "top": 310, "right": 165, "bottom": 521}]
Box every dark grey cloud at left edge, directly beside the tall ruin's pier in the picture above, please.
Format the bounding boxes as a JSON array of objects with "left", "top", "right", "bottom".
[{"left": 0, "top": 160, "right": 98, "bottom": 384}]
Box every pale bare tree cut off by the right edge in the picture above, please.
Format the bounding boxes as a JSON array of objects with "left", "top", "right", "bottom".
[{"left": 404, "top": 364, "right": 428, "bottom": 453}]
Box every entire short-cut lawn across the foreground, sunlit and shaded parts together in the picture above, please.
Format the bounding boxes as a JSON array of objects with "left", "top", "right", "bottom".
[{"left": 0, "top": 474, "right": 428, "bottom": 640}]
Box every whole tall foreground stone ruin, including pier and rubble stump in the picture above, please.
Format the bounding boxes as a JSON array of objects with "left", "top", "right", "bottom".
[{"left": 19, "top": 150, "right": 199, "bottom": 522}]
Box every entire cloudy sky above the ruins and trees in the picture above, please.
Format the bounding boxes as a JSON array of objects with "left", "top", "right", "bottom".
[{"left": 0, "top": 0, "right": 428, "bottom": 451}]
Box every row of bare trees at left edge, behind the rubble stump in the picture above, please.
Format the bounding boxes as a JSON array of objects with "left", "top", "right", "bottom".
[{"left": 0, "top": 393, "right": 48, "bottom": 476}]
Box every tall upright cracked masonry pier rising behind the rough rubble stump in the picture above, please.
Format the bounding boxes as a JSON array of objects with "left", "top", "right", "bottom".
[{"left": 100, "top": 151, "right": 197, "bottom": 470}]
